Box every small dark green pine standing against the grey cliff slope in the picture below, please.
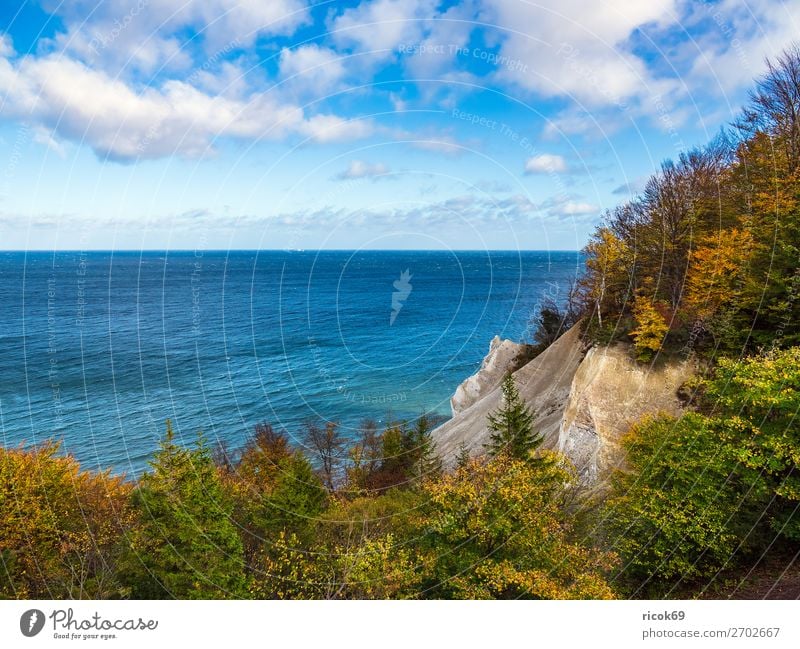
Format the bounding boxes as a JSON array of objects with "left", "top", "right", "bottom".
[{"left": 486, "top": 373, "right": 544, "bottom": 460}]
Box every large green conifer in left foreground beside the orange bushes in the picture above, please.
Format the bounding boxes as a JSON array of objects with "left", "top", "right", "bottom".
[{"left": 123, "top": 421, "right": 245, "bottom": 599}]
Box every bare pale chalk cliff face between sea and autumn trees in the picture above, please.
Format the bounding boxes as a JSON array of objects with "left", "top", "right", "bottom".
[{"left": 433, "top": 325, "right": 697, "bottom": 485}]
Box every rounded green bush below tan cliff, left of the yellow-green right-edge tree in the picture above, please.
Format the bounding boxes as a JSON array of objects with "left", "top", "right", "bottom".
[{"left": 603, "top": 412, "right": 765, "bottom": 597}]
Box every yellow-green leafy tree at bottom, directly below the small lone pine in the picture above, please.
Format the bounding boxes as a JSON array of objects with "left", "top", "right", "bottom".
[{"left": 412, "top": 454, "right": 614, "bottom": 599}]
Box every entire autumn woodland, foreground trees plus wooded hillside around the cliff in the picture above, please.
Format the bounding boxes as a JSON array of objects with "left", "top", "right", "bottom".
[{"left": 0, "top": 47, "right": 800, "bottom": 599}]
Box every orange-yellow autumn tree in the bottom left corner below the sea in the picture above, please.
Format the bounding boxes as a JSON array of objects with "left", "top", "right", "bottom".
[{"left": 0, "top": 442, "right": 132, "bottom": 599}]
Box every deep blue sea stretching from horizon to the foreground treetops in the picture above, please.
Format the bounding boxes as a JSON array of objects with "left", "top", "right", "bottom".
[{"left": 0, "top": 251, "right": 583, "bottom": 474}]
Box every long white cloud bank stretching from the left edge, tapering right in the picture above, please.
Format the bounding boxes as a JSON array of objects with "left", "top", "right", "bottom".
[{"left": 0, "top": 48, "right": 372, "bottom": 160}]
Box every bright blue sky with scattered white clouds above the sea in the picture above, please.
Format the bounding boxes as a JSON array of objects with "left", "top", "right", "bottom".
[{"left": 0, "top": 0, "right": 800, "bottom": 250}]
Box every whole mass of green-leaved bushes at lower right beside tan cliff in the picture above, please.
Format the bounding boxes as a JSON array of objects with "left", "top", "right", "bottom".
[{"left": 607, "top": 348, "right": 800, "bottom": 593}]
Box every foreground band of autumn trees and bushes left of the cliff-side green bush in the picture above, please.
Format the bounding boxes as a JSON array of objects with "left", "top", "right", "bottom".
[{"left": 0, "top": 408, "right": 614, "bottom": 599}]
